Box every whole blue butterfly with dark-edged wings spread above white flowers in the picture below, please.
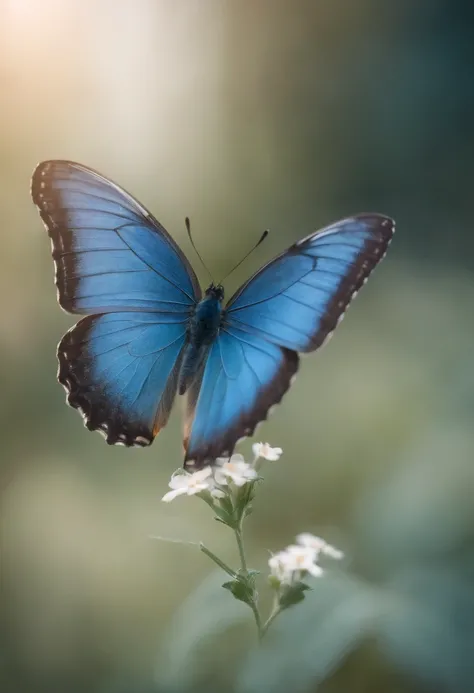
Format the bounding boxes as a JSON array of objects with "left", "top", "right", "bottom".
[{"left": 32, "top": 161, "right": 394, "bottom": 469}]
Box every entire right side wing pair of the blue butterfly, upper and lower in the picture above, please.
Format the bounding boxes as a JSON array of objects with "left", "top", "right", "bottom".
[{"left": 186, "top": 214, "right": 394, "bottom": 468}]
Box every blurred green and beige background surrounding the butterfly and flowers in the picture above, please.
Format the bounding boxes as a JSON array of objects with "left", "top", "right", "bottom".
[{"left": 0, "top": 0, "right": 474, "bottom": 693}]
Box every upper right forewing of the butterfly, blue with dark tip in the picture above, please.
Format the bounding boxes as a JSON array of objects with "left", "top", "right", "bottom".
[{"left": 224, "top": 214, "right": 395, "bottom": 352}]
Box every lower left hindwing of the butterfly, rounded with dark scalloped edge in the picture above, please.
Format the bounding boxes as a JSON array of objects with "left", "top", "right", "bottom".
[{"left": 58, "top": 311, "right": 187, "bottom": 446}]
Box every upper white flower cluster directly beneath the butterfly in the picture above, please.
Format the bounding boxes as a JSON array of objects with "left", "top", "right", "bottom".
[{"left": 162, "top": 443, "right": 283, "bottom": 503}]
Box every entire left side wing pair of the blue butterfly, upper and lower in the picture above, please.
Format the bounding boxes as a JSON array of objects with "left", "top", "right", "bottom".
[{"left": 32, "top": 161, "right": 201, "bottom": 445}]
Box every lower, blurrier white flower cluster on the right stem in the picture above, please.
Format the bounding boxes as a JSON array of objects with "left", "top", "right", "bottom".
[{"left": 268, "top": 532, "right": 344, "bottom": 585}]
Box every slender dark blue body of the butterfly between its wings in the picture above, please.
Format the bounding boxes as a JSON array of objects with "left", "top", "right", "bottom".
[{"left": 178, "top": 284, "right": 224, "bottom": 395}]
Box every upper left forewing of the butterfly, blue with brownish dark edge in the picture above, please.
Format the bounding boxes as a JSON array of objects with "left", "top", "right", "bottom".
[{"left": 32, "top": 161, "right": 201, "bottom": 314}]
